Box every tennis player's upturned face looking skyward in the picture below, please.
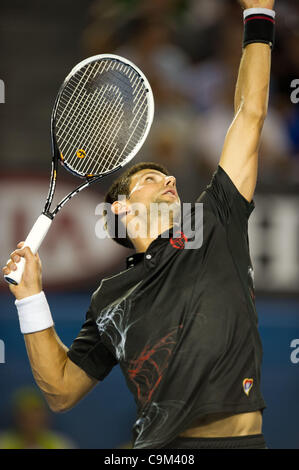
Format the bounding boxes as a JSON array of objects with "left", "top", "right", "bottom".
[{"left": 128, "top": 169, "right": 180, "bottom": 207}]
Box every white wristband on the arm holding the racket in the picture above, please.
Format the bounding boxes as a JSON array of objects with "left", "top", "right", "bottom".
[{"left": 15, "top": 291, "right": 54, "bottom": 334}]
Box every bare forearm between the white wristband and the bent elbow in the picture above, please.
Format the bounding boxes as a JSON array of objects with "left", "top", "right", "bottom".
[{"left": 24, "top": 327, "right": 68, "bottom": 411}]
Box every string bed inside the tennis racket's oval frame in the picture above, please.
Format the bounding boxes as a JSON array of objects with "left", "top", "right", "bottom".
[{"left": 55, "top": 59, "right": 148, "bottom": 176}]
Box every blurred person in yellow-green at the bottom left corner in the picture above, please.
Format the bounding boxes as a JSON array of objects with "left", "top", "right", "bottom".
[{"left": 0, "top": 387, "right": 75, "bottom": 449}]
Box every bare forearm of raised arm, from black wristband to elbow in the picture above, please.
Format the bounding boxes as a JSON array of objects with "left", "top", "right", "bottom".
[{"left": 235, "top": 43, "right": 271, "bottom": 118}]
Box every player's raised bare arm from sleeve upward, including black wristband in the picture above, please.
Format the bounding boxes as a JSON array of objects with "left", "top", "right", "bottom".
[{"left": 219, "top": 0, "right": 275, "bottom": 202}]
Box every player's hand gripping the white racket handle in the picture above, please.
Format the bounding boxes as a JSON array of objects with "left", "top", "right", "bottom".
[{"left": 2, "top": 242, "right": 42, "bottom": 300}]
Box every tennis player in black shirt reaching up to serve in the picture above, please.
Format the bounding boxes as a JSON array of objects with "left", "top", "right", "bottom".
[{"left": 3, "top": 0, "right": 275, "bottom": 449}]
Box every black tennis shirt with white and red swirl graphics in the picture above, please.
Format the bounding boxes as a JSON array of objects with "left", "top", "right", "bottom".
[{"left": 68, "top": 166, "right": 265, "bottom": 449}]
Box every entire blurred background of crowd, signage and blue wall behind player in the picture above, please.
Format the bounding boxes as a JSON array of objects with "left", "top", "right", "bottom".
[{"left": 0, "top": 0, "right": 299, "bottom": 449}]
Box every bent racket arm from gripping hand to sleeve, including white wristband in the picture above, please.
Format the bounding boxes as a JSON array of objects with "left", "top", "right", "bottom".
[{"left": 3, "top": 248, "right": 98, "bottom": 412}]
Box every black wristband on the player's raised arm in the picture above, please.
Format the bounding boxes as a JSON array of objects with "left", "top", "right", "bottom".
[{"left": 243, "top": 13, "right": 275, "bottom": 49}]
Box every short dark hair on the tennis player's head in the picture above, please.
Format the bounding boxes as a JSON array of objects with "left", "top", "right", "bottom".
[{"left": 104, "top": 162, "right": 169, "bottom": 248}]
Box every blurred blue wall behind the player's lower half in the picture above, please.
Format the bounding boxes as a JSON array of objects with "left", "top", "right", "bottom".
[{"left": 0, "top": 293, "right": 299, "bottom": 449}]
